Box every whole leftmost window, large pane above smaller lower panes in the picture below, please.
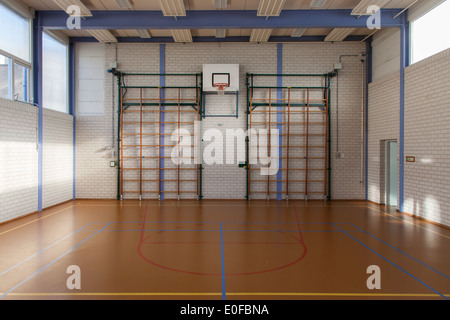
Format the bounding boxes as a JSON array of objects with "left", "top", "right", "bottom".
[{"left": 0, "top": 3, "right": 31, "bottom": 102}]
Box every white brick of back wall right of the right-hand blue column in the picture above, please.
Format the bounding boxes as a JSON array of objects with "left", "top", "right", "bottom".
[{"left": 283, "top": 43, "right": 365, "bottom": 199}]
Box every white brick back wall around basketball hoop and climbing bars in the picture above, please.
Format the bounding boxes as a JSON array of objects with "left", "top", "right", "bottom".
[{"left": 77, "top": 43, "right": 365, "bottom": 199}]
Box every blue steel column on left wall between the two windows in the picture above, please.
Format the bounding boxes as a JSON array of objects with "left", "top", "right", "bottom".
[{"left": 33, "top": 12, "right": 43, "bottom": 212}]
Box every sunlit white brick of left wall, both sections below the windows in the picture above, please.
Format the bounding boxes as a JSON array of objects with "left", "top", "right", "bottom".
[{"left": 0, "top": 99, "right": 73, "bottom": 222}]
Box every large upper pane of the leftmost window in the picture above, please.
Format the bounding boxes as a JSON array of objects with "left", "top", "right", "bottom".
[{"left": 0, "top": 4, "right": 31, "bottom": 62}]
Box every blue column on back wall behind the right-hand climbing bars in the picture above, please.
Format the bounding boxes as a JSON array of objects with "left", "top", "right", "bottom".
[{"left": 276, "top": 43, "right": 289, "bottom": 200}]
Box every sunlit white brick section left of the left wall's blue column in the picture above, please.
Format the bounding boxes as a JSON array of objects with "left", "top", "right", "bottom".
[{"left": 0, "top": 99, "right": 38, "bottom": 223}]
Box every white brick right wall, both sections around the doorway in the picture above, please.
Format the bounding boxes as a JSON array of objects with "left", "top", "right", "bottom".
[{"left": 369, "top": 42, "right": 450, "bottom": 225}]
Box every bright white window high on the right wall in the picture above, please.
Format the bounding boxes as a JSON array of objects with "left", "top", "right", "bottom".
[{"left": 411, "top": 0, "right": 450, "bottom": 63}]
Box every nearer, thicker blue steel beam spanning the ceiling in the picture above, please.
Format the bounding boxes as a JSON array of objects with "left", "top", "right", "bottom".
[{"left": 41, "top": 9, "right": 403, "bottom": 30}]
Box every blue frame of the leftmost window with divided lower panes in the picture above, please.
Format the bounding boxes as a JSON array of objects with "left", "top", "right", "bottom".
[{"left": 0, "top": 1, "right": 33, "bottom": 103}]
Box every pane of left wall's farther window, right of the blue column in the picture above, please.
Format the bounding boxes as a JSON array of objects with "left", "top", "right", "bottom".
[{"left": 42, "top": 33, "right": 68, "bottom": 113}]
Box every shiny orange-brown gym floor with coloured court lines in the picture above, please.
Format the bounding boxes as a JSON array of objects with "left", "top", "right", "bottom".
[{"left": 0, "top": 200, "right": 450, "bottom": 300}]
